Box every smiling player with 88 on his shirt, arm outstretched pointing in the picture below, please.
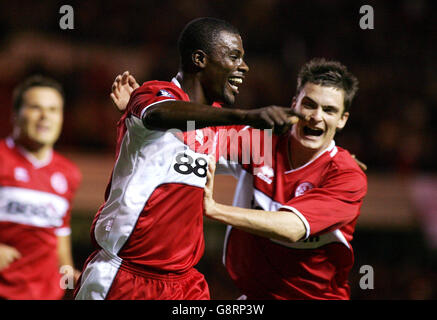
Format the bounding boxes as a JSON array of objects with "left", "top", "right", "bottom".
[{"left": 75, "top": 18, "right": 296, "bottom": 300}]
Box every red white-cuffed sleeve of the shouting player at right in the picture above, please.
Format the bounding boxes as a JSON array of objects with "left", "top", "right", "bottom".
[{"left": 280, "top": 170, "right": 367, "bottom": 239}]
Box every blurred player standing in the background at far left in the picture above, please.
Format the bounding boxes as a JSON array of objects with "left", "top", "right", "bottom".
[{"left": 0, "top": 76, "right": 81, "bottom": 300}]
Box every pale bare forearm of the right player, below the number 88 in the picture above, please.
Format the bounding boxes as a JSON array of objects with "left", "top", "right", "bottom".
[{"left": 205, "top": 203, "right": 306, "bottom": 242}]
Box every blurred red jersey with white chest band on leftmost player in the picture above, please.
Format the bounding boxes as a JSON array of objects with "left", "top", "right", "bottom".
[{"left": 0, "top": 138, "right": 81, "bottom": 300}]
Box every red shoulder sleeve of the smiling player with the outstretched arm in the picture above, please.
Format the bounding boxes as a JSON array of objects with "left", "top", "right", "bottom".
[{"left": 127, "top": 81, "right": 183, "bottom": 118}]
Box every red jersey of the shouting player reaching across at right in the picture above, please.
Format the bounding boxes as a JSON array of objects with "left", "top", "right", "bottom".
[{"left": 220, "top": 129, "right": 367, "bottom": 299}]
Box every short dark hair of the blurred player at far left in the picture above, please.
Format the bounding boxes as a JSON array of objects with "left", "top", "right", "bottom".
[{"left": 12, "top": 74, "right": 64, "bottom": 113}]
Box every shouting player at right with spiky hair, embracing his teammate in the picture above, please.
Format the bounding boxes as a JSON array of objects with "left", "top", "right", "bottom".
[{"left": 204, "top": 59, "right": 367, "bottom": 299}]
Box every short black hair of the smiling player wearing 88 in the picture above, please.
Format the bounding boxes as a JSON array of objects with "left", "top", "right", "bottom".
[{"left": 178, "top": 17, "right": 240, "bottom": 71}]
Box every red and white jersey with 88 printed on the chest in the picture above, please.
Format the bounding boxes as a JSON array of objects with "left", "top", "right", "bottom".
[{"left": 76, "top": 79, "right": 225, "bottom": 299}]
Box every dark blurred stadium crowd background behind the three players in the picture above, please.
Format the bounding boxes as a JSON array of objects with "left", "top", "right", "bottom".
[{"left": 0, "top": 0, "right": 437, "bottom": 299}]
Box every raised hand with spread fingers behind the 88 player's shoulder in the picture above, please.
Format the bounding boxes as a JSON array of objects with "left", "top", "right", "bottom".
[{"left": 110, "top": 71, "right": 140, "bottom": 112}]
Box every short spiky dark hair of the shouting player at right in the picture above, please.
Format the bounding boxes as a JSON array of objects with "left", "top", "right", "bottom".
[{"left": 296, "top": 58, "right": 358, "bottom": 112}]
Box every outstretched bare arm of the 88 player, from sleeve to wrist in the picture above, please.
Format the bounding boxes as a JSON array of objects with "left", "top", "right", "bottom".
[{"left": 143, "top": 100, "right": 246, "bottom": 131}]
